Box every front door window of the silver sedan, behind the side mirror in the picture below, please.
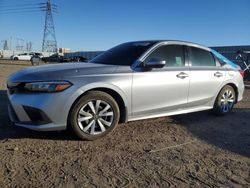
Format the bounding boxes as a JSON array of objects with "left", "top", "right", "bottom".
[{"left": 144, "top": 45, "right": 185, "bottom": 67}]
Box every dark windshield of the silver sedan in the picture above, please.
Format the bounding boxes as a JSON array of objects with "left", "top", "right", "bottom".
[{"left": 90, "top": 42, "right": 156, "bottom": 66}]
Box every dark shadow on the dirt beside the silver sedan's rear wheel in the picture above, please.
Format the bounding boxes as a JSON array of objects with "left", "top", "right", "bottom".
[{"left": 172, "top": 108, "right": 250, "bottom": 157}]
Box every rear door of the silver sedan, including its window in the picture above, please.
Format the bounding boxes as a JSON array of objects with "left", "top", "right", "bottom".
[{"left": 187, "top": 47, "right": 226, "bottom": 107}]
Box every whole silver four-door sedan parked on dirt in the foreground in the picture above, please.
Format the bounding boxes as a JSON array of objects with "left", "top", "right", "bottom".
[{"left": 7, "top": 41, "right": 244, "bottom": 140}]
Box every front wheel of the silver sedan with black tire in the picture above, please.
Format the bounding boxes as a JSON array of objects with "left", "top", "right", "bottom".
[{"left": 69, "top": 91, "right": 120, "bottom": 140}]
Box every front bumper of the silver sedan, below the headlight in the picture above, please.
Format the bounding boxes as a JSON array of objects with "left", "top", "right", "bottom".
[{"left": 8, "top": 88, "right": 75, "bottom": 131}]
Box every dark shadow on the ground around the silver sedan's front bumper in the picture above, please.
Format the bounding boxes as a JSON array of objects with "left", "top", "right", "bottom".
[{"left": 0, "top": 90, "right": 79, "bottom": 140}]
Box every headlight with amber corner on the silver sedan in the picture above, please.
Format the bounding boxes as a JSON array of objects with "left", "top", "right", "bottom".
[{"left": 24, "top": 81, "right": 72, "bottom": 93}]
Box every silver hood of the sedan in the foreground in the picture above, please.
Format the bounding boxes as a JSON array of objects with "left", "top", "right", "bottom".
[{"left": 8, "top": 63, "right": 118, "bottom": 82}]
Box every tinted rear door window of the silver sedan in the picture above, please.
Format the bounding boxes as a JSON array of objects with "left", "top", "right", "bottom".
[{"left": 189, "top": 47, "right": 216, "bottom": 66}]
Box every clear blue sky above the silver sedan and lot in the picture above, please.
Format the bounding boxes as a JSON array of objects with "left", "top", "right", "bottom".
[{"left": 0, "top": 0, "right": 250, "bottom": 51}]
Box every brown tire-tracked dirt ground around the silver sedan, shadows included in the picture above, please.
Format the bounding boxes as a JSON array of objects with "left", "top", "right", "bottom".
[{"left": 0, "top": 61, "right": 250, "bottom": 187}]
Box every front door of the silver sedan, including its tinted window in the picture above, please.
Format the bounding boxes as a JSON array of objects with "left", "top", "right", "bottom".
[{"left": 132, "top": 45, "right": 190, "bottom": 119}]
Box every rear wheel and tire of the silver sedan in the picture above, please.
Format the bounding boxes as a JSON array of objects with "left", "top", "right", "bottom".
[{"left": 213, "top": 85, "right": 236, "bottom": 115}]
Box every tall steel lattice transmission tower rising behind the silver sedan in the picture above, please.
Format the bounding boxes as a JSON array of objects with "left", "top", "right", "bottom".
[{"left": 42, "top": 0, "right": 57, "bottom": 52}]
